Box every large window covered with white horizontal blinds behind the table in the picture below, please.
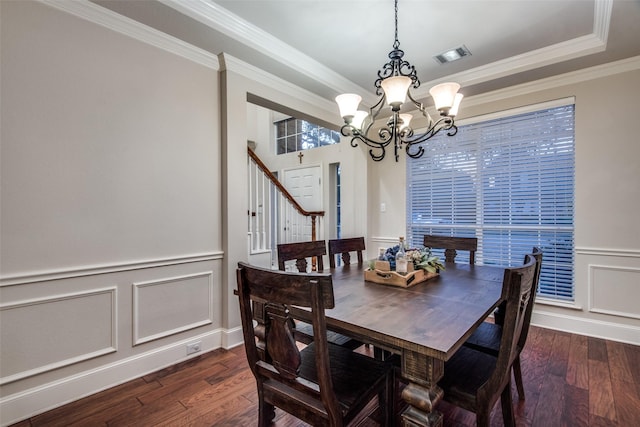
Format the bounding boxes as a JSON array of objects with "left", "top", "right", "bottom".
[{"left": 407, "top": 100, "right": 575, "bottom": 301}]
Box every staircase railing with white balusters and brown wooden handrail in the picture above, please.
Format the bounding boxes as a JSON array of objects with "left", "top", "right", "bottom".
[{"left": 247, "top": 147, "right": 324, "bottom": 268}]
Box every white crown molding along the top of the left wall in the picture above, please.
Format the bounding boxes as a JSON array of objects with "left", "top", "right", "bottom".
[{"left": 39, "top": 0, "right": 219, "bottom": 71}]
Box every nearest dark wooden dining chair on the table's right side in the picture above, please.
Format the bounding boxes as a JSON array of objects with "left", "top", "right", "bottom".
[{"left": 438, "top": 255, "right": 537, "bottom": 427}]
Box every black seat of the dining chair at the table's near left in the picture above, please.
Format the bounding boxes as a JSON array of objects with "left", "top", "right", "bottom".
[{"left": 300, "top": 343, "right": 392, "bottom": 412}]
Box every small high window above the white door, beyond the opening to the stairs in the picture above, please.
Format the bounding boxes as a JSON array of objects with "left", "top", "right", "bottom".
[{"left": 274, "top": 117, "right": 340, "bottom": 154}]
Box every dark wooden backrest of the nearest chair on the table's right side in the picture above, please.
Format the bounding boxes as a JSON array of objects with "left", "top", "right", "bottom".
[{"left": 479, "top": 255, "right": 537, "bottom": 407}]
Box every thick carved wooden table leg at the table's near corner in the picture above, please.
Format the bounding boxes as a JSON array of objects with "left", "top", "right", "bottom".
[{"left": 402, "top": 351, "right": 444, "bottom": 427}]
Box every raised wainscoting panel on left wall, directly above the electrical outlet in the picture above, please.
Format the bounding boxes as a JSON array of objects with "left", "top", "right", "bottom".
[{"left": 133, "top": 271, "right": 213, "bottom": 346}]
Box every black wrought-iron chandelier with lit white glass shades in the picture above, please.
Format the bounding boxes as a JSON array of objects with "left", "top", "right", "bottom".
[{"left": 336, "top": 0, "right": 462, "bottom": 162}]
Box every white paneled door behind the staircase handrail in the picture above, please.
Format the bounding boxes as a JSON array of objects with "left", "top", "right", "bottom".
[{"left": 284, "top": 166, "right": 322, "bottom": 242}]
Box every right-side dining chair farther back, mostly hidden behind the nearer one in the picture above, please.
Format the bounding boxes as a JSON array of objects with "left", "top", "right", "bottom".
[{"left": 464, "top": 247, "right": 542, "bottom": 400}]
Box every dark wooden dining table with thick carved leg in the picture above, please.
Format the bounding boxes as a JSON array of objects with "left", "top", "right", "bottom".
[{"left": 290, "top": 263, "right": 504, "bottom": 426}]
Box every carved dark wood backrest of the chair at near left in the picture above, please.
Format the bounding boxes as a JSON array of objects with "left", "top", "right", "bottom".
[{"left": 236, "top": 263, "right": 340, "bottom": 419}]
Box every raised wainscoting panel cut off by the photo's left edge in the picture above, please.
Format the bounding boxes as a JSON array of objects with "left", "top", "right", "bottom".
[{"left": 0, "top": 287, "right": 117, "bottom": 384}]
